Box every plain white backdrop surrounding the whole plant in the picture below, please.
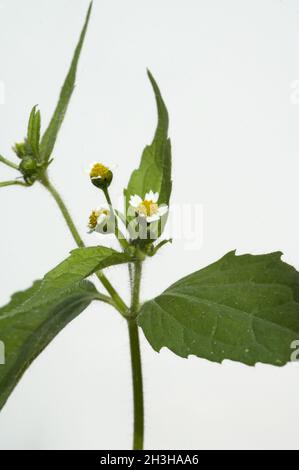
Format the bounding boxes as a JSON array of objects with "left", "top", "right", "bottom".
[{"left": 0, "top": 0, "right": 299, "bottom": 449}]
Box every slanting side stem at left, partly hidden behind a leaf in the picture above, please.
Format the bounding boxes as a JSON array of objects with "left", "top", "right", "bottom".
[{"left": 40, "top": 175, "right": 128, "bottom": 316}]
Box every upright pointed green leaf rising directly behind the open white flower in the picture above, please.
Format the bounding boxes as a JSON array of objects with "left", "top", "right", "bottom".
[{"left": 125, "top": 71, "right": 172, "bottom": 209}]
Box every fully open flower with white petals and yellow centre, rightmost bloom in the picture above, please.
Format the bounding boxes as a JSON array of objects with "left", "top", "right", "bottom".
[{"left": 129, "top": 190, "right": 168, "bottom": 223}]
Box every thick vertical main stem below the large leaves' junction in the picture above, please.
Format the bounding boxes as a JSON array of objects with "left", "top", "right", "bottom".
[{"left": 128, "top": 318, "right": 144, "bottom": 450}]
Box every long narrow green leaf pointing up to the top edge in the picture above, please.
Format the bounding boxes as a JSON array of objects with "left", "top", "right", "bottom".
[{"left": 40, "top": 2, "right": 92, "bottom": 161}]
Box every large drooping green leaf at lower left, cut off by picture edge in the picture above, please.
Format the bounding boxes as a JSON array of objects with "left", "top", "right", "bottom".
[{"left": 0, "top": 281, "right": 97, "bottom": 409}]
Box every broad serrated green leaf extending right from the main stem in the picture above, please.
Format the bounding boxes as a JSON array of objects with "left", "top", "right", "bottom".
[{"left": 138, "top": 252, "right": 299, "bottom": 366}]
